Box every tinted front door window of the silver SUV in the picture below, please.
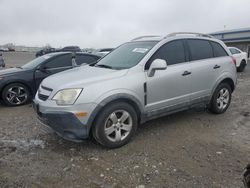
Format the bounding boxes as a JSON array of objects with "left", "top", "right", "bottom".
[{"left": 145, "top": 40, "right": 186, "bottom": 70}]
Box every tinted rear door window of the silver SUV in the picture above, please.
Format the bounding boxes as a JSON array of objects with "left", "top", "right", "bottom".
[{"left": 187, "top": 39, "right": 213, "bottom": 61}]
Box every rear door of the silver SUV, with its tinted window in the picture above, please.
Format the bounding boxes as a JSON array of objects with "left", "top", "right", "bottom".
[{"left": 186, "top": 39, "right": 228, "bottom": 104}]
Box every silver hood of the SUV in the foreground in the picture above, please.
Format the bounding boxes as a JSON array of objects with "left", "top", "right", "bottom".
[{"left": 42, "top": 65, "right": 128, "bottom": 90}]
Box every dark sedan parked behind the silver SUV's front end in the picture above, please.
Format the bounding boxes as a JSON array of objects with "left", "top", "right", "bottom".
[{"left": 0, "top": 52, "right": 100, "bottom": 106}]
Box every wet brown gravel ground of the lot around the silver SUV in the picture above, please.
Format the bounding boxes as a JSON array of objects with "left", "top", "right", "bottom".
[{"left": 0, "top": 54, "right": 250, "bottom": 188}]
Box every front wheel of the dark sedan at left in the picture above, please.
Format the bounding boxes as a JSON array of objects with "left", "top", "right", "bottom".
[{"left": 2, "top": 83, "right": 31, "bottom": 106}]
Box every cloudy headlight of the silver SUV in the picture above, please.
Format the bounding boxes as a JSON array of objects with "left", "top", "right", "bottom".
[{"left": 52, "top": 89, "right": 82, "bottom": 105}]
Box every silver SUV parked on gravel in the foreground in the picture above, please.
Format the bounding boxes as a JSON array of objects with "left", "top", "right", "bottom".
[{"left": 34, "top": 33, "right": 236, "bottom": 148}]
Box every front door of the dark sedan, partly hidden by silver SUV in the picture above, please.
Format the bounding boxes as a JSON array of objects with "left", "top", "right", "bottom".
[{"left": 34, "top": 54, "right": 72, "bottom": 88}]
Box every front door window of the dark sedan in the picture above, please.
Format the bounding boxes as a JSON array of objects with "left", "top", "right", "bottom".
[{"left": 45, "top": 54, "right": 72, "bottom": 69}]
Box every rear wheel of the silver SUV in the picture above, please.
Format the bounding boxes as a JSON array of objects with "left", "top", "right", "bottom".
[{"left": 209, "top": 83, "right": 232, "bottom": 114}]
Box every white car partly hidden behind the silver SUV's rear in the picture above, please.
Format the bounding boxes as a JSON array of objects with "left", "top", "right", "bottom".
[{"left": 228, "top": 47, "right": 247, "bottom": 72}]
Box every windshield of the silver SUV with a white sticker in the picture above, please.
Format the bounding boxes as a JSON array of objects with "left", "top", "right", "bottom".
[{"left": 95, "top": 41, "right": 157, "bottom": 70}]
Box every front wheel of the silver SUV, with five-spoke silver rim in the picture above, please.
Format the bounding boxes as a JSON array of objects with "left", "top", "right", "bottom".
[{"left": 92, "top": 102, "right": 138, "bottom": 148}]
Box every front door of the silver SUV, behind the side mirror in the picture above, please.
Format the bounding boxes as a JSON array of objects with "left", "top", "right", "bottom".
[{"left": 145, "top": 40, "right": 191, "bottom": 113}]
